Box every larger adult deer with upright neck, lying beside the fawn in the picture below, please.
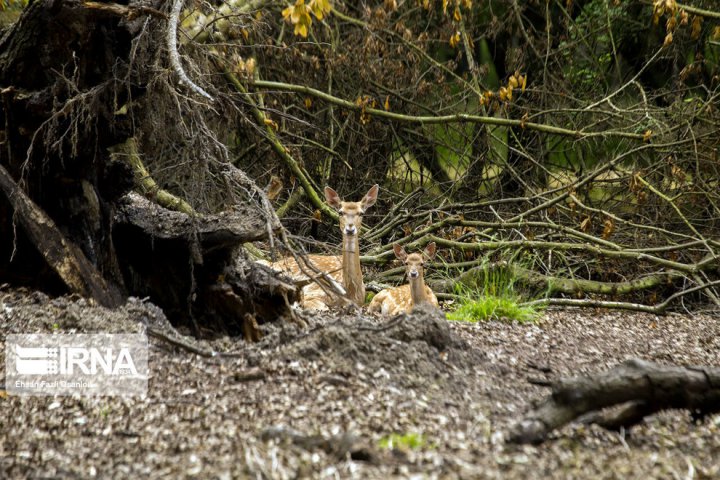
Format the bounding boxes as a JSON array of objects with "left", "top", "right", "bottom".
[{"left": 262, "top": 185, "right": 379, "bottom": 310}]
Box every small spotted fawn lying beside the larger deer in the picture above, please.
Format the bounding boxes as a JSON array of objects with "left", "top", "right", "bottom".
[{"left": 369, "top": 242, "right": 439, "bottom": 315}]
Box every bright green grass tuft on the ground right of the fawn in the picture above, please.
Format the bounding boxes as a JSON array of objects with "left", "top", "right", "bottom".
[{"left": 447, "top": 265, "right": 541, "bottom": 323}]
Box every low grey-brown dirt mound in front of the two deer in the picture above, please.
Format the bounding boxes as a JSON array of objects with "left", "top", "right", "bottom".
[{"left": 254, "top": 308, "right": 484, "bottom": 392}]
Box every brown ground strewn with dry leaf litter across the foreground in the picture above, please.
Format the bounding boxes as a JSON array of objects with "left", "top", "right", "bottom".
[{"left": 0, "top": 289, "right": 720, "bottom": 479}]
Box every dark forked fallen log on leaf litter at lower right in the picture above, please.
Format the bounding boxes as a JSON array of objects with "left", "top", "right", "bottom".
[{"left": 507, "top": 359, "right": 720, "bottom": 443}]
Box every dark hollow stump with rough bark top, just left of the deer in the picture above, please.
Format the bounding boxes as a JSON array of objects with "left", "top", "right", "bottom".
[{"left": 113, "top": 194, "right": 297, "bottom": 340}]
